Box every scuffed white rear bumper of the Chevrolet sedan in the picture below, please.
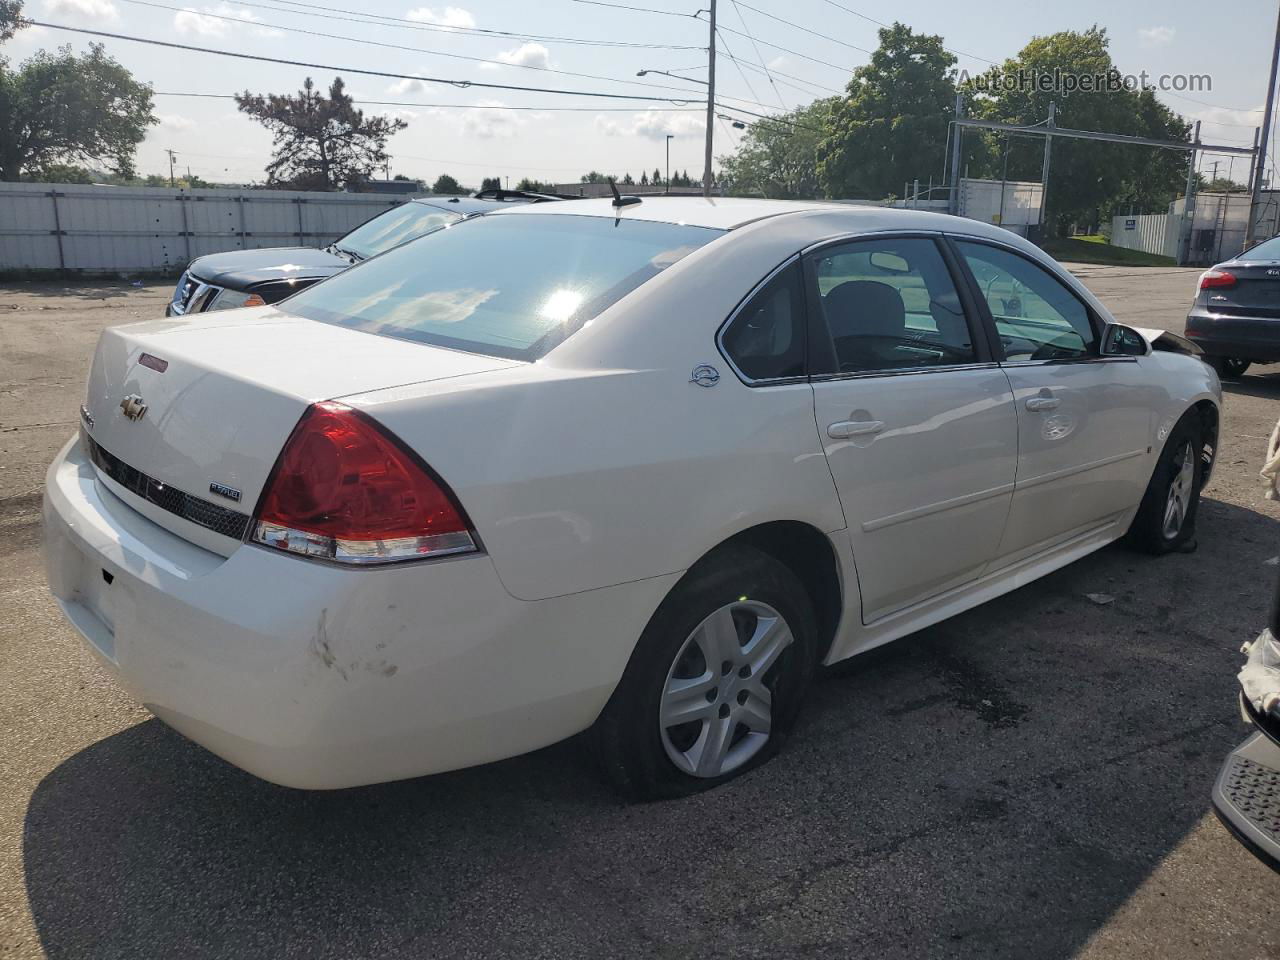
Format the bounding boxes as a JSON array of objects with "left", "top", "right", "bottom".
[{"left": 44, "top": 440, "right": 676, "bottom": 788}]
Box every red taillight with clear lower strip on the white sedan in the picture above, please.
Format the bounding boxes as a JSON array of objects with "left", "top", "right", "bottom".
[{"left": 252, "top": 403, "right": 477, "bottom": 564}]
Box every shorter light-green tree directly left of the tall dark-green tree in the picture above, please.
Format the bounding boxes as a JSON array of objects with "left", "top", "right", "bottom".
[{"left": 716, "top": 99, "right": 835, "bottom": 200}]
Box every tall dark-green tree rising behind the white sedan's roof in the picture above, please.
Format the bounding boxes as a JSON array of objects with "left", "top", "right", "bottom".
[{"left": 818, "top": 23, "right": 956, "bottom": 200}]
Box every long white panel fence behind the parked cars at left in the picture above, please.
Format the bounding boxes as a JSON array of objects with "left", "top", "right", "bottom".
[{"left": 0, "top": 183, "right": 404, "bottom": 273}]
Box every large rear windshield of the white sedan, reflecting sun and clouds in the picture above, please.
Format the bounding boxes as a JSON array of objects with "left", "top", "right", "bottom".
[{"left": 280, "top": 214, "right": 723, "bottom": 361}]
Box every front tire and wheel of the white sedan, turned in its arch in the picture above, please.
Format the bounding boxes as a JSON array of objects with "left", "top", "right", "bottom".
[{"left": 1129, "top": 411, "right": 1204, "bottom": 554}]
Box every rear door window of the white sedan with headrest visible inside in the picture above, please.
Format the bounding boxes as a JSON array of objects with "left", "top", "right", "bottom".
[{"left": 812, "top": 237, "right": 975, "bottom": 372}]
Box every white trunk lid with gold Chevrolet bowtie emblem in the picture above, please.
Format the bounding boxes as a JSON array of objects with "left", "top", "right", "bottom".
[{"left": 82, "top": 307, "right": 516, "bottom": 556}]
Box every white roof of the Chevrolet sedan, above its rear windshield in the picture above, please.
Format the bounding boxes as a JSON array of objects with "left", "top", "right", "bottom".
[{"left": 486, "top": 195, "right": 1014, "bottom": 239}]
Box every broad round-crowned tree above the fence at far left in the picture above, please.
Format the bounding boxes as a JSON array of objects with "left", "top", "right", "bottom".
[{"left": 0, "top": 44, "right": 156, "bottom": 180}]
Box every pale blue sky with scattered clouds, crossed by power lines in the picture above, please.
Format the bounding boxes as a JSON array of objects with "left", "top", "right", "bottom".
[{"left": 0, "top": 0, "right": 1280, "bottom": 186}]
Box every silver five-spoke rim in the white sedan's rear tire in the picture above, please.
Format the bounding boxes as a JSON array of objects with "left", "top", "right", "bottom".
[{"left": 658, "top": 598, "right": 795, "bottom": 777}]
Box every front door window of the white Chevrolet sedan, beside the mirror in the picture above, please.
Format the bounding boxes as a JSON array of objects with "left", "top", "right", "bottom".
[{"left": 956, "top": 241, "right": 1097, "bottom": 360}]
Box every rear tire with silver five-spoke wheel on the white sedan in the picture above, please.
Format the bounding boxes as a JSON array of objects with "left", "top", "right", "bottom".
[{"left": 591, "top": 547, "right": 817, "bottom": 800}]
